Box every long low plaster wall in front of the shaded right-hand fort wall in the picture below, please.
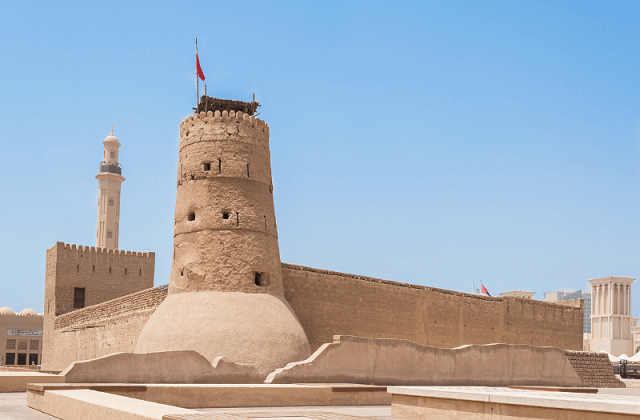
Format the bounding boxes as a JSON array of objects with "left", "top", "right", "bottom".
[{"left": 265, "top": 336, "right": 583, "bottom": 386}]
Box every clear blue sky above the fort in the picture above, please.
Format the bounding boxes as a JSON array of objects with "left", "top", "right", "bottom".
[{"left": 0, "top": 0, "right": 640, "bottom": 314}]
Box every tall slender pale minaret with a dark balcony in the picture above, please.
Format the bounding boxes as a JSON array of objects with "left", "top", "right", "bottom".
[{"left": 96, "top": 127, "right": 124, "bottom": 249}]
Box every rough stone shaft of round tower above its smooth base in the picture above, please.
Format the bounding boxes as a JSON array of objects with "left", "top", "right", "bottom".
[{"left": 169, "top": 111, "right": 283, "bottom": 295}]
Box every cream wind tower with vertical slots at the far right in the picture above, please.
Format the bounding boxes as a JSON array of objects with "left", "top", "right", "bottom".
[{"left": 588, "top": 277, "right": 635, "bottom": 356}]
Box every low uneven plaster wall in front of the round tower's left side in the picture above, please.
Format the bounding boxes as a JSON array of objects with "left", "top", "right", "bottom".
[{"left": 61, "top": 350, "right": 263, "bottom": 384}]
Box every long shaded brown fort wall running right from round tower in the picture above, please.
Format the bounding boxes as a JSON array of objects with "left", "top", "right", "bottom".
[{"left": 282, "top": 264, "right": 583, "bottom": 351}]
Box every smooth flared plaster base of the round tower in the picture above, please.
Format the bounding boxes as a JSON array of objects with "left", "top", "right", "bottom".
[{"left": 135, "top": 291, "right": 310, "bottom": 376}]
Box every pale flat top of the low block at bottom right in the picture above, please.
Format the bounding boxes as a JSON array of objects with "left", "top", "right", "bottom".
[{"left": 387, "top": 386, "right": 640, "bottom": 415}]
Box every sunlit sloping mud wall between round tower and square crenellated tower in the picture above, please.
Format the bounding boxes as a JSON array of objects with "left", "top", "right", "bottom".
[{"left": 43, "top": 285, "right": 167, "bottom": 371}]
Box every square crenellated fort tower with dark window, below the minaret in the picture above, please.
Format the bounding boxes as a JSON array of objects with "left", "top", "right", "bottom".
[{"left": 42, "top": 242, "right": 155, "bottom": 367}]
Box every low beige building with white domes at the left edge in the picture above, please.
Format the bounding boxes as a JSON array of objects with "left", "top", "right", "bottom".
[{"left": 0, "top": 307, "right": 43, "bottom": 366}]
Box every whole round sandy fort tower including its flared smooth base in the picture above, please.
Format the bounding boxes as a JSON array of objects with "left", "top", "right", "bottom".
[{"left": 136, "top": 97, "right": 310, "bottom": 374}]
